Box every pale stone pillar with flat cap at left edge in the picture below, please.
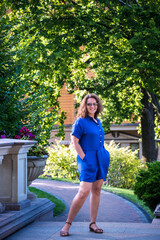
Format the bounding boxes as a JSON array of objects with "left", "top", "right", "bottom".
[{"left": 0, "top": 139, "right": 36, "bottom": 210}]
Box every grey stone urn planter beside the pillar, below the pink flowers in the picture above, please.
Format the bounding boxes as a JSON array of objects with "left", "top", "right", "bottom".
[{"left": 27, "top": 156, "right": 48, "bottom": 200}]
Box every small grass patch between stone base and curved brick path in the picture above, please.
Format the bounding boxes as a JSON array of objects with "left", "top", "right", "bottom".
[{"left": 29, "top": 187, "right": 65, "bottom": 217}]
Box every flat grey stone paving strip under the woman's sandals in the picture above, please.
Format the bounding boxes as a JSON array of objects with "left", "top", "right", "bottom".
[{"left": 6, "top": 219, "right": 160, "bottom": 240}]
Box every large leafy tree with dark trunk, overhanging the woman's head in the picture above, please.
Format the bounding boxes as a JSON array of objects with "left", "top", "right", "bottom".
[{"left": 3, "top": 0, "right": 160, "bottom": 161}]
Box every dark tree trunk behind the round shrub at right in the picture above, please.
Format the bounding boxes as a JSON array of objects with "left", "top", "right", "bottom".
[{"left": 141, "top": 89, "right": 157, "bottom": 162}]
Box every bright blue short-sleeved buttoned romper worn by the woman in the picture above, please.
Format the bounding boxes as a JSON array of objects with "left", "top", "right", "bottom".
[{"left": 72, "top": 116, "right": 110, "bottom": 182}]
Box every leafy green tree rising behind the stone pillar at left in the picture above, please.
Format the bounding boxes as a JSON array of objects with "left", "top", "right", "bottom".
[{"left": 0, "top": 1, "right": 65, "bottom": 144}]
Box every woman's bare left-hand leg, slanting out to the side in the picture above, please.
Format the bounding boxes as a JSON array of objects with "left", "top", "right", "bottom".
[{"left": 62, "top": 182, "right": 92, "bottom": 232}]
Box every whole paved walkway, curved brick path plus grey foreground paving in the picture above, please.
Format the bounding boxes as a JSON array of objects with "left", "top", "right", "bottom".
[{"left": 6, "top": 179, "right": 160, "bottom": 240}]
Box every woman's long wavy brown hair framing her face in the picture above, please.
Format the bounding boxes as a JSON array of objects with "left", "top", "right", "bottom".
[{"left": 77, "top": 93, "right": 103, "bottom": 118}]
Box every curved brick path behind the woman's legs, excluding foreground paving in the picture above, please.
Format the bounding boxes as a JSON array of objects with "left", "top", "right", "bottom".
[{"left": 32, "top": 179, "right": 148, "bottom": 223}]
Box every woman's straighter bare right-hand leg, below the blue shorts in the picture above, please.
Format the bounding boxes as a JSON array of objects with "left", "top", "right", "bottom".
[{"left": 90, "top": 179, "right": 103, "bottom": 229}]
